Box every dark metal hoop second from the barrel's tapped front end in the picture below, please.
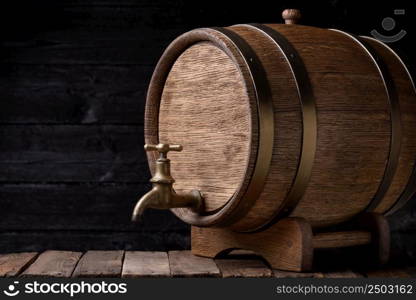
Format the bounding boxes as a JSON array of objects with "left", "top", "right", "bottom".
[{"left": 239, "top": 24, "right": 317, "bottom": 231}]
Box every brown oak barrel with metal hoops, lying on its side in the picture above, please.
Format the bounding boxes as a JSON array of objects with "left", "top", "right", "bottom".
[{"left": 145, "top": 24, "right": 416, "bottom": 232}]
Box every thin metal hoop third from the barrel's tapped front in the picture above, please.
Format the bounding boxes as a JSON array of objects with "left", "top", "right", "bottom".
[{"left": 331, "top": 29, "right": 402, "bottom": 211}]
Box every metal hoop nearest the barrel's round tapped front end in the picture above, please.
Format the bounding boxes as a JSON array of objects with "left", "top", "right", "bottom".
[{"left": 211, "top": 27, "right": 274, "bottom": 226}]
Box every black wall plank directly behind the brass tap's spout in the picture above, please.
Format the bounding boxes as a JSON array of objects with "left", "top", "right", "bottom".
[{"left": 0, "top": 183, "right": 187, "bottom": 232}]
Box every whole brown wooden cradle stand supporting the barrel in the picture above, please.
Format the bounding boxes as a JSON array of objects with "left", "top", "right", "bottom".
[{"left": 192, "top": 213, "right": 390, "bottom": 272}]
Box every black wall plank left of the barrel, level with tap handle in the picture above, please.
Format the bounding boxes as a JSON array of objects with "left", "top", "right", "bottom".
[{"left": 0, "top": 125, "right": 149, "bottom": 183}]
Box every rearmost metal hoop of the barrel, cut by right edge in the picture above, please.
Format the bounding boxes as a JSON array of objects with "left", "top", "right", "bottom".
[{"left": 362, "top": 36, "right": 416, "bottom": 215}]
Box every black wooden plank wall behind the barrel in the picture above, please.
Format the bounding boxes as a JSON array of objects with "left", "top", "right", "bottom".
[{"left": 0, "top": 0, "right": 416, "bottom": 261}]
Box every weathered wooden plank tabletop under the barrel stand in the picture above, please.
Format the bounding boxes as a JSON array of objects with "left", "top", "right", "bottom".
[{"left": 0, "top": 250, "right": 416, "bottom": 278}]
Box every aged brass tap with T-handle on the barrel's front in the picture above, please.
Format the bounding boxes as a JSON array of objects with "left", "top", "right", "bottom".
[{"left": 132, "top": 144, "right": 203, "bottom": 221}]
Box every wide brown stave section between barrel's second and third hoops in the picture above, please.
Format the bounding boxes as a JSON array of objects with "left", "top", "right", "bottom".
[{"left": 271, "top": 25, "right": 390, "bottom": 226}]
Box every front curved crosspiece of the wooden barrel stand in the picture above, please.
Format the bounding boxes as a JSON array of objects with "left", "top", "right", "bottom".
[{"left": 191, "top": 218, "right": 313, "bottom": 272}]
